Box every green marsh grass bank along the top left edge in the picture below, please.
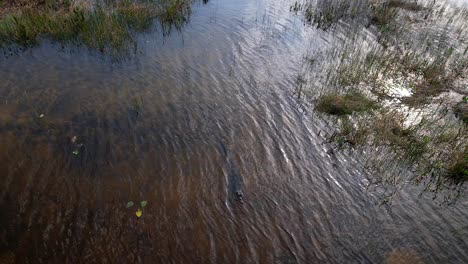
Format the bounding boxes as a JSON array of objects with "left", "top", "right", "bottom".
[{"left": 0, "top": 0, "right": 190, "bottom": 51}]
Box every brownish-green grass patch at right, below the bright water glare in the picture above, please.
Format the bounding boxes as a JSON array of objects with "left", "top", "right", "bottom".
[{"left": 329, "top": 108, "right": 468, "bottom": 201}]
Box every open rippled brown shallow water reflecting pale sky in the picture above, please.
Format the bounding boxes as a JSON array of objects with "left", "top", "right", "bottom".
[{"left": 0, "top": 0, "right": 468, "bottom": 263}]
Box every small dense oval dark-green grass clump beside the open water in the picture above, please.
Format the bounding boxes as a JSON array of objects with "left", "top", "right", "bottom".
[{"left": 316, "top": 92, "right": 377, "bottom": 116}]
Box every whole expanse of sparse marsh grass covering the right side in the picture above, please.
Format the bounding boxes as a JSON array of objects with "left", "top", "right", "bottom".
[{"left": 291, "top": 0, "right": 468, "bottom": 200}]
